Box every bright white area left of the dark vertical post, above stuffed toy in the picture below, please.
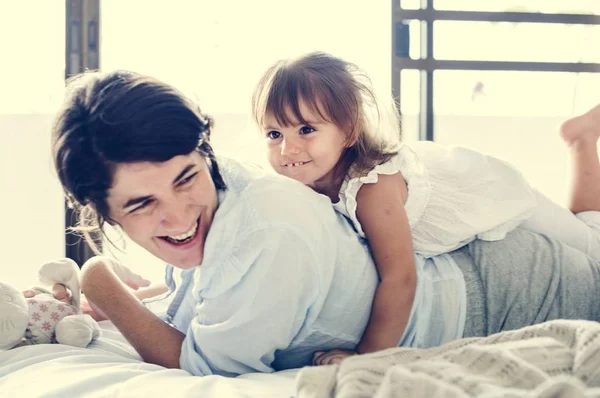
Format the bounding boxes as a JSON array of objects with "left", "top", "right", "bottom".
[{"left": 0, "top": 1, "right": 65, "bottom": 287}]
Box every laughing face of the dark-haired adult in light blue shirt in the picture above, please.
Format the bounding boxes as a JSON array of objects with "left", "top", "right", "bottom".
[{"left": 107, "top": 151, "right": 218, "bottom": 269}]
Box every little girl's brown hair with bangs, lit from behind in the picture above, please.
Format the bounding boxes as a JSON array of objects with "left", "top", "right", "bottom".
[{"left": 252, "top": 52, "right": 401, "bottom": 174}]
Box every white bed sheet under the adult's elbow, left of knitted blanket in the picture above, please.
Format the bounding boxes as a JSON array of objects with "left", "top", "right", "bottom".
[{"left": 0, "top": 322, "right": 298, "bottom": 398}]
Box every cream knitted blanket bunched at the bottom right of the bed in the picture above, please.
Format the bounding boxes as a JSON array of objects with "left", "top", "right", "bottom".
[{"left": 296, "top": 320, "right": 600, "bottom": 398}]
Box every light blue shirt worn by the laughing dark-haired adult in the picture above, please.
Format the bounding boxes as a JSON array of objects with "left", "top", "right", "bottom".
[{"left": 152, "top": 158, "right": 466, "bottom": 376}]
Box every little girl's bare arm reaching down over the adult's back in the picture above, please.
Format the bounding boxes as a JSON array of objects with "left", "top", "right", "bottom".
[{"left": 357, "top": 173, "right": 417, "bottom": 353}]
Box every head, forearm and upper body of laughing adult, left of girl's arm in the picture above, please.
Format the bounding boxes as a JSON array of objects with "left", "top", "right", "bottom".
[{"left": 52, "top": 72, "right": 377, "bottom": 374}]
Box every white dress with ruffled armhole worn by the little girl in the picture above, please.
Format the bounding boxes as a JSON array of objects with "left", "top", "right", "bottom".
[{"left": 334, "top": 141, "right": 537, "bottom": 257}]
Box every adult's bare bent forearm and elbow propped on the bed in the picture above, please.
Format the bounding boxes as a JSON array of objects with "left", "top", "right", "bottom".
[{"left": 81, "top": 257, "right": 185, "bottom": 368}]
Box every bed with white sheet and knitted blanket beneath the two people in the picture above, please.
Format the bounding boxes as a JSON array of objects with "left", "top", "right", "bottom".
[{"left": 0, "top": 320, "right": 600, "bottom": 398}]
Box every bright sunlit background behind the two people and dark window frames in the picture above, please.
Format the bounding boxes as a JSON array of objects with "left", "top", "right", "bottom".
[{"left": 0, "top": 0, "right": 600, "bottom": 287}]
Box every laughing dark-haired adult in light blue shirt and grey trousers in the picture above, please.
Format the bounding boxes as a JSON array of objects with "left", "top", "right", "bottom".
[{"left": 52, "top": 72, "right": 600, "bottom": 375}]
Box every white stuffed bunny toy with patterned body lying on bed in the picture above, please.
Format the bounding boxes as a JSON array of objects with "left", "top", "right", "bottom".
[{"left": 0, "top": 258, "right": 100, "bottom": 350}]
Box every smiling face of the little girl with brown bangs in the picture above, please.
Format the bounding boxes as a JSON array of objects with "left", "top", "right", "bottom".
[{"left": 262, "top": 101, "right": 346, "bottom": 191}]
